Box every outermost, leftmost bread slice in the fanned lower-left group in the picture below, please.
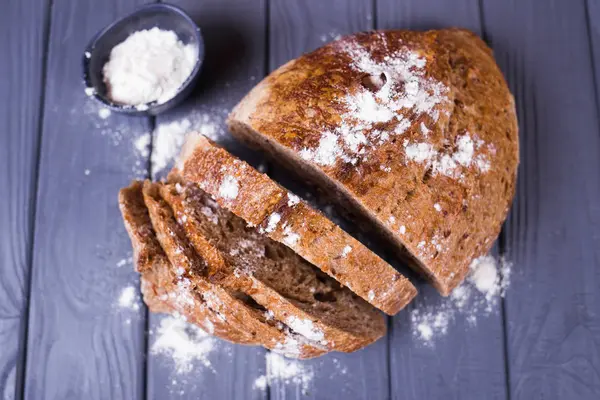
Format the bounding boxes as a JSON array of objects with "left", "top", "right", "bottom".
[{"left": 119, "top": 182, "right": 259, "bottom": 344}]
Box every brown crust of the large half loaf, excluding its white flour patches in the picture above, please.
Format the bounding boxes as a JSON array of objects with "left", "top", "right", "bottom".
[{"left": 229, "top": 29, "right": 519, "bottom": 295}]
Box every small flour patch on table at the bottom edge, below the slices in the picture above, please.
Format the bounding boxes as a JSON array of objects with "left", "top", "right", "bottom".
[{"left": 254, "top": 353, "right": 315, "bottom": 393}]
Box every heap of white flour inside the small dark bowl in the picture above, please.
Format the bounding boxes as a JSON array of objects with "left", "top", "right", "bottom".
[{"left": 103, "top": 28, "right": 198, "bottom": 109}]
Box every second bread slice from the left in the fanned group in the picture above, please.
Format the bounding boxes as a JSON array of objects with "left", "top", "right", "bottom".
[{"left": 143, "top": 181, "right": 328, "bottom": 359}]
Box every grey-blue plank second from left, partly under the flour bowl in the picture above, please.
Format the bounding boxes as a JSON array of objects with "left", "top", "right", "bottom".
[{"left": 24, "top": 0, "right": 149, "bottom": 400}]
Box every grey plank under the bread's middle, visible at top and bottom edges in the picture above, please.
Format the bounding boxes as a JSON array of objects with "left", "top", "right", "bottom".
[{"left": 269, "top": 0, "right": 389, "bottom": 399}]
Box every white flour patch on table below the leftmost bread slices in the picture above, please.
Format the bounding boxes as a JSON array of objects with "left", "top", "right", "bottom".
[{"left": 152, "top": 316, "right": 217, "bottom": 374}]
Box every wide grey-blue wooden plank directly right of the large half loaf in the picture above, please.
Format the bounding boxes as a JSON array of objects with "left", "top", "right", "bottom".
[{"left": 483, "top": 0, "right": 600, "bottom": 399}]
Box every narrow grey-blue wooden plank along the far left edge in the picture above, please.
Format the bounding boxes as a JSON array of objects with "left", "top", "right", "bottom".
[{"left": 0, "top": 0, "right": 48, "bottom": 399}]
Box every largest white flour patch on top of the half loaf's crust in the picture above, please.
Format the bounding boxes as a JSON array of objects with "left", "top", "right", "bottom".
[{"left": 299, "top": 36, "right": 449, "bottom": 172}]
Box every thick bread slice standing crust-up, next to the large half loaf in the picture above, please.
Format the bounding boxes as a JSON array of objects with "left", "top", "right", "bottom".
[{"left": 170, "top": 133, "right": 416, "bottom": 314}]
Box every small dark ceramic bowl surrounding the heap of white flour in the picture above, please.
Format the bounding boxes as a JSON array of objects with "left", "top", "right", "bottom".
[{"left": 83, "top": 3, "right": 204, "bottom": 115}]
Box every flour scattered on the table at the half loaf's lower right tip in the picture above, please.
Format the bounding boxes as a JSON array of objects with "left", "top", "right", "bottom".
[{"left": 410, "top": 255, "right": 512, "bottom": 345}]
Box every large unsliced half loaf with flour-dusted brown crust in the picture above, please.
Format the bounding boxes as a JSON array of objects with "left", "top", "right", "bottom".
[{"left": 227, "top": 29, "right": 519, "bottom": 295}]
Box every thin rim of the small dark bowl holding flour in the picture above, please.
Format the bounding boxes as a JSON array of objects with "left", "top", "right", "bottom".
[{"left": 82, "top": 3, "right": 204, "bottom": 115}]
